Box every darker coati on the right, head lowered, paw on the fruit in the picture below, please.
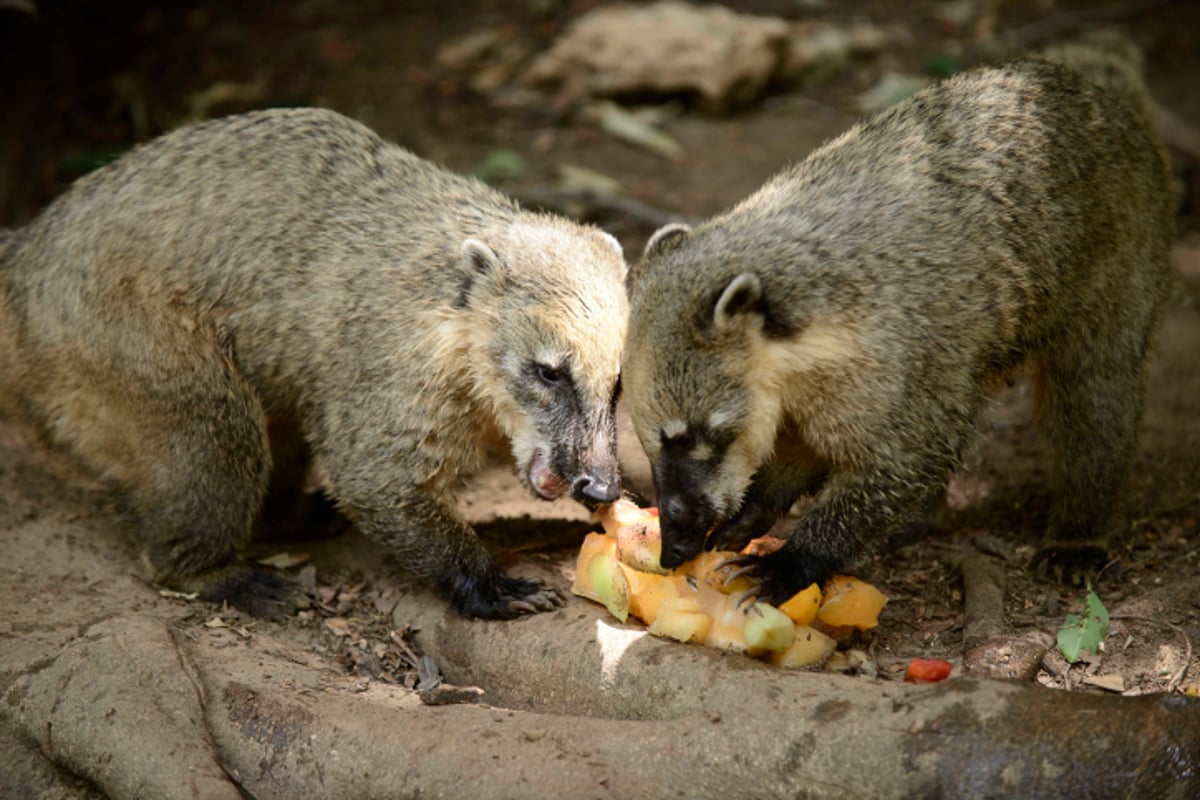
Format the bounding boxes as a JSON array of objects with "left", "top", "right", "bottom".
[{"left": 623, "top": 35, "right": 1174, "bottom": 602}]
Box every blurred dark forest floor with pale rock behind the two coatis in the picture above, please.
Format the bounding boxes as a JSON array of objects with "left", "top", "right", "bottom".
[{"left": 0, "top": 0, "right": 1200, "bottom": 254}]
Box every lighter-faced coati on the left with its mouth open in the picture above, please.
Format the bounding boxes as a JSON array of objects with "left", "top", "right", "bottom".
[{"left": 0, "top": 109, "right": 629, "bottom": 618}]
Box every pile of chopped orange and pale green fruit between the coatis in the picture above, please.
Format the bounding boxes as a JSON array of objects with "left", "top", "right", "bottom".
[{"left": 571, "top": 500, "right": 887, "bottom": 667}]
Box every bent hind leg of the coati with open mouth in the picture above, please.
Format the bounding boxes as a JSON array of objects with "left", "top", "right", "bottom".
[{"left": 43, "top": 319, "right": 292, "bottom": 615}]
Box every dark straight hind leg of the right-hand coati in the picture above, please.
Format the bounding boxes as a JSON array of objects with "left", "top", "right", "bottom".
[{"left": 1033, "top": 323, "right": 1148, "bottom": 585}]
